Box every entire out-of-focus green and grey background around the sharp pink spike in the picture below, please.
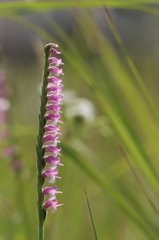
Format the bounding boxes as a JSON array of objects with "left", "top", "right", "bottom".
[{"left": 0, "top": 1, "right": 159, "bottom": 240}]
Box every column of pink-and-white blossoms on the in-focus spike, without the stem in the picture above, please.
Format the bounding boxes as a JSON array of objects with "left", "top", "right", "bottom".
[{"left": 41, "top": 44, "right": 64, "bottom": 212}]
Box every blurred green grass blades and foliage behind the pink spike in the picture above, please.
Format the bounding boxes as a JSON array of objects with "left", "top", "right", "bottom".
[{"left": 0, "top": 0, "right": 159, "bottom": 240}]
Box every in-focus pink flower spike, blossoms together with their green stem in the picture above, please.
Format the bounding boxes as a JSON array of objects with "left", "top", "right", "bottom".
[{"left": 36, "top": 43, "right": 64, "bottom": 216}]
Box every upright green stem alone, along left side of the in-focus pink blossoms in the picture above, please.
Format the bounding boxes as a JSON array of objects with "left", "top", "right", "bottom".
[{"left": 36, "top": 44, "right": 50, "bottom": 240}]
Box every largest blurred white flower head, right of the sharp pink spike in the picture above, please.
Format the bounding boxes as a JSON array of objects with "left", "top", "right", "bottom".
[{"left": 66, "top": 98, "right": 96, "bottom": 123}]
